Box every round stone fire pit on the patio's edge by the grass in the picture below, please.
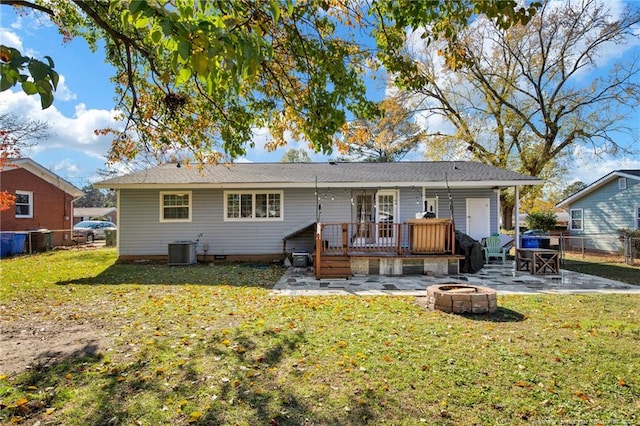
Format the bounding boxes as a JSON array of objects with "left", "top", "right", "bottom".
[{"left": 427, "top": 284, "right": 498, "bottom": 314}]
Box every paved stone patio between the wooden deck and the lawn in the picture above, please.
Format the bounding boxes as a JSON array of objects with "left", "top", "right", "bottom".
[{"left": 273, "top": 262, "right": 640, "bottom": 296}]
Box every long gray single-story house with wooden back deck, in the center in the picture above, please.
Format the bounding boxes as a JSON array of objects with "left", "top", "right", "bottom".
[{"left": 95, "top": 161, "right": 543, "bottom": 277}]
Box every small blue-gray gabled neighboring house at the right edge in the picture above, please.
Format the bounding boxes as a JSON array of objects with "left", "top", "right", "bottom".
[{"left": 556, "top": 170, "right": 640, "bottom": 252}]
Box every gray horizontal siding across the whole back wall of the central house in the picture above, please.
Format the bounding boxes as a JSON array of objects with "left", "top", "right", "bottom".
[{"left": 118, "top": 188, "right": 498, "bottom": 256}]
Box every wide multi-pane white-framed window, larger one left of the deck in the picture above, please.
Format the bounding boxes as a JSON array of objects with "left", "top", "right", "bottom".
[{"left": 224, "top": 191, "right": 282, "bottom": 221}]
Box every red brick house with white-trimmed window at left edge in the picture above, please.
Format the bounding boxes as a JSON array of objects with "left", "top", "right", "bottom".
[{"left": 0, "top": 158, "right": 83, "bottom": 245}]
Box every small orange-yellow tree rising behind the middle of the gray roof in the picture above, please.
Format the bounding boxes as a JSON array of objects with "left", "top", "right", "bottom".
[{"left": 336, "top": 98, "right": 425, "bottom": 163}]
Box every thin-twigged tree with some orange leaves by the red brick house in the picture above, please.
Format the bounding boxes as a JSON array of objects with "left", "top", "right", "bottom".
[{"left": 0, "top": 113, "right": 49, "bottom": 211}]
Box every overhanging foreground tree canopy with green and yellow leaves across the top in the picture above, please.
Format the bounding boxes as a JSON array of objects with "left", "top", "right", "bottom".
[{"left": 0, "top": 0, "right": 532, "bottom": 166}]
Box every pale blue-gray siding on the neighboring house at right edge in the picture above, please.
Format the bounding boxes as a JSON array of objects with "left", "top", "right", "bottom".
[{"left": 569, "top": 178, "right": 640, "bottom": 251}]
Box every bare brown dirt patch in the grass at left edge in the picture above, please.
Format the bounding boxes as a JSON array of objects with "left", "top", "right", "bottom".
[{"left": 0, "top": 317, "right": 111, "bottom": 375}]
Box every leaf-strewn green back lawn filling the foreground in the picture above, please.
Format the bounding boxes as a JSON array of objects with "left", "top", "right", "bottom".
[{"left": 0, "top": 249, "right": 640, "bottom": 425}]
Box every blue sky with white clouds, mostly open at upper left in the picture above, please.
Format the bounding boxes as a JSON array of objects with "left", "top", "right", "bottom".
[{"left": 0, "top": 0, "right": 640, "bottom": 187}]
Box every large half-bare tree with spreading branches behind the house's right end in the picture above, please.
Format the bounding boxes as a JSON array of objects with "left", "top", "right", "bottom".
[{"left": 405, "top": 0, "right": 640, "bottom": 230}]
